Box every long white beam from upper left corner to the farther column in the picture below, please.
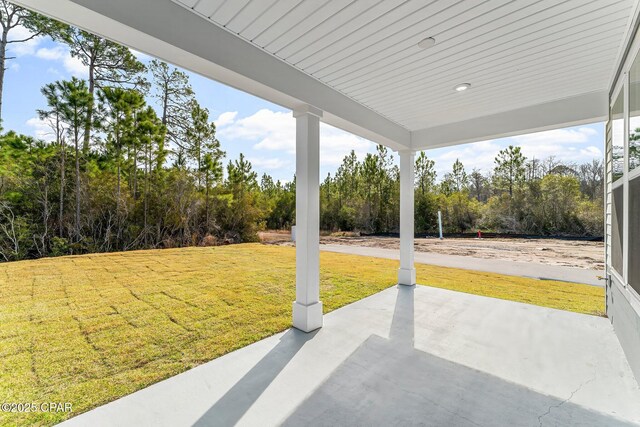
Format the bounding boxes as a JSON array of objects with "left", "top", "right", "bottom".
[{"left": 14, "top": 0, "right": 411, "bottom": 149}]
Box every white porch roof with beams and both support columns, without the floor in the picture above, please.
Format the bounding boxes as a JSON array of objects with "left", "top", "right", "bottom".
[{"left": 16, "top": 0, "right": 637, "bottom": 332}]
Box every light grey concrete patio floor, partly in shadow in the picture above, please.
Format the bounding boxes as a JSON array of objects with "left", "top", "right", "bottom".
[{"left": 64, "top": 286, "right": 640, "bottom": 426}]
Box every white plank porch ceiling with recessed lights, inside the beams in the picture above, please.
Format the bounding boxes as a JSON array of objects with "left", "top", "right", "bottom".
[{"left": 174, "top": 0, "right": 634, "bottom": 131}]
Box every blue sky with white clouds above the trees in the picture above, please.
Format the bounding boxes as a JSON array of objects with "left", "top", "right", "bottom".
[{"left": 3, "top": 28, "right": 603, "bottom": 181}]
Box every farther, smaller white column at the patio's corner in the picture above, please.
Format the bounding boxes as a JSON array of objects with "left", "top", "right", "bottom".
[{"left": 398, "top": 151, "right": 416, "bottom": 286}]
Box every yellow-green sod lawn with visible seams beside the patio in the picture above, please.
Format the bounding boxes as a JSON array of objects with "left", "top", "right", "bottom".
[{"left": 0, "top": 244, "right": 604, "bottom": 425}]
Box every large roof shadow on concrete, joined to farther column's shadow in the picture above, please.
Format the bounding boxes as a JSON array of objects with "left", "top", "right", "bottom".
[{"left": 284, "top": 286, "right": 633, "bottom": 426}]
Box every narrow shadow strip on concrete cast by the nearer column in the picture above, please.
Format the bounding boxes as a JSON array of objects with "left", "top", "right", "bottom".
[{"left": 194, "top": 328, "right": 317, "bottom": 427}]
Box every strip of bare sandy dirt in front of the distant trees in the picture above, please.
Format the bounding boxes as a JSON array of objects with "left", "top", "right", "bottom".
[{"left": 260, "top": 231, "right": 604, "bottom": 270}]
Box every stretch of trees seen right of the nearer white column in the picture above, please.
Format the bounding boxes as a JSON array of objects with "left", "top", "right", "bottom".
[{"left": 320, "top": 146, "right": 604, "bottom": 236}]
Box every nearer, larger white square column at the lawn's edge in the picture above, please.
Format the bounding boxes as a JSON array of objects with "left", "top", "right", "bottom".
[{"left": 293, "top": 106, "right": 322, "bottom": 332}]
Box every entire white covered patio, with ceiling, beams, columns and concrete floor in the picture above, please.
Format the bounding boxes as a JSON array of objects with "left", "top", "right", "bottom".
[{"left": 11, "top": 0, "right": 640, "bottom": 426}]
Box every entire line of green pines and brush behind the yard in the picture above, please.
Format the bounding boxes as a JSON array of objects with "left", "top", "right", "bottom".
[{"left": 0, "top": 0, "right": 603, "bottom": 261}]
